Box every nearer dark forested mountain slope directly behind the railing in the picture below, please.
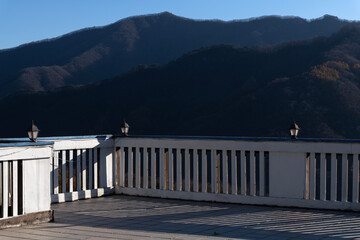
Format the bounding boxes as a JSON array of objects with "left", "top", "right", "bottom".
[{"left": 0, "top": 25, "right": 360, "bottom": 138}]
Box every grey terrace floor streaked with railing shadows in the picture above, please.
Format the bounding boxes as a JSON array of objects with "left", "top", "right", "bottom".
[{"left": 0, "top": 195, "right": 360, "bottom": 240}]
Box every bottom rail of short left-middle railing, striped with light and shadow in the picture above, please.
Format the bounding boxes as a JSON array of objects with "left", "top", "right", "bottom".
[{"left": 51, "top": 187, "right": 115, "bottom": 203}]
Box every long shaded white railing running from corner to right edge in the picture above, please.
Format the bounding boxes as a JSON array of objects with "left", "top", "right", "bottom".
[{"left": 115, "top": 137, "right": 360, "bottom": 210}]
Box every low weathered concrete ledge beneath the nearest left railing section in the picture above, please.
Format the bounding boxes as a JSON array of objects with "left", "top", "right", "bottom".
[{"left": 0, "top": 210, "right": 54, "bottom": 229}]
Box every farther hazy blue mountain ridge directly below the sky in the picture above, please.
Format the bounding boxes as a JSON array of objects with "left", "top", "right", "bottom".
[{"left": 0, "top": 12, "right": 348, "bottom": 98}]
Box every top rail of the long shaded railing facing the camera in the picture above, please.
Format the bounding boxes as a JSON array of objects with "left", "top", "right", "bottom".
[{"left": 119, "top": 135, "right": 360, "bottom": 143}]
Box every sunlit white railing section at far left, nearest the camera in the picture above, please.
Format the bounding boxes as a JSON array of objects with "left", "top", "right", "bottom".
[{"left": 0, "top": 141, "right": 53, "bottom": 221}]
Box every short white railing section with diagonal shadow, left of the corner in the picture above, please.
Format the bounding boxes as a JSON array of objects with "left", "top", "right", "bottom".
[{"left": 46, "top": 136, "right": 114, "bottom": 203}]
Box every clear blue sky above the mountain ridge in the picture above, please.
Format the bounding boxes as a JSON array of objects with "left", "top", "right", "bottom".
[{"left": 0, "top": 0, "right": 360, "bottom": 49}]
